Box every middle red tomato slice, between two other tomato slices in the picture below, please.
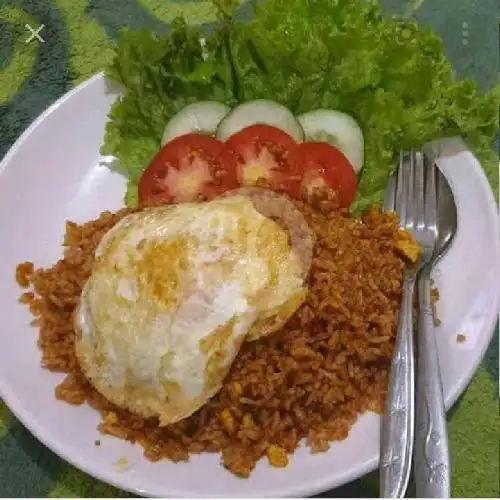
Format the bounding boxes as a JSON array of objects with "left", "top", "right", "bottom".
[{"left": 226, "top": 124, "right": 300, "bottom": 194}]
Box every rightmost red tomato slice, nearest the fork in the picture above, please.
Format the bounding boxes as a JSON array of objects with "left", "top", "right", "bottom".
[{"left": 295, "top": 141, "right": 357, "bottom": 208}]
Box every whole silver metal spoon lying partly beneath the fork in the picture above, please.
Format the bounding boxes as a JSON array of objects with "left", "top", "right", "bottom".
[{"left": 413, "top": 155, "right": 458, "bottom": 498}]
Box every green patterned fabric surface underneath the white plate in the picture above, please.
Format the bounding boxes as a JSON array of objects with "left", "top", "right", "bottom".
[{"left": 0, "top": 0, "right": 500, "bottom": 497}]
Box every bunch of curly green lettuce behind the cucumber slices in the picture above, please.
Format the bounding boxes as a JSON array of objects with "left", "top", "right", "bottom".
[{"left": 103, "top": 0, "right": 500, "bottom": 210}]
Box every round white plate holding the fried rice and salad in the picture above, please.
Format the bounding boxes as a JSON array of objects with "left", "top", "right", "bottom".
[{"left": 0, "top": 75, "right": 500, "bottom": 497}]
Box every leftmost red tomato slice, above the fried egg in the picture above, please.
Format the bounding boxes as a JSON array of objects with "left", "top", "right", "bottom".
[{"left": 139, "top": 134, "right": 238, "bottom": 204}]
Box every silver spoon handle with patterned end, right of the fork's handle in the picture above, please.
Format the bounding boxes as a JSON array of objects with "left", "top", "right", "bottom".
[{"left": 414, "top": 267, "right": 450, "bottom": 498}]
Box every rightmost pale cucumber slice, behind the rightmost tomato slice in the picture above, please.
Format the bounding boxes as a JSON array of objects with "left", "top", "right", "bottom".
[{"left": 297, "top": 109, "right": 365, "bottom": 172}]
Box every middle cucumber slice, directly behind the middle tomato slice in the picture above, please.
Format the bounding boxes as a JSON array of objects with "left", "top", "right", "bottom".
[{"left": 217, "top": 99, "right": 304, "bottom": 142}]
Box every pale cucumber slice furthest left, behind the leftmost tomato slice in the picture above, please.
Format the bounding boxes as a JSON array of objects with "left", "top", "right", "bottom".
[{"left": 161, "top": 101, "right": 231, "bottom": 146}]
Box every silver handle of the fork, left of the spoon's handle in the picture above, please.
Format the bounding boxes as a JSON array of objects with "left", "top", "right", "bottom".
[{"left": 380, "top": 273, "right": 415, "bottom": 498}]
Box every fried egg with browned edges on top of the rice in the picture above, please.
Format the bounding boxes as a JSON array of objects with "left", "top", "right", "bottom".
[{"left": 75, "top": 196, "right": 306, "bottom": 425}]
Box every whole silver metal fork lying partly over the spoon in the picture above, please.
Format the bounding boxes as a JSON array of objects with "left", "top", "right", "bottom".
[{"left": 380, "top": 150, "right": 437, "bottom": 498}]
